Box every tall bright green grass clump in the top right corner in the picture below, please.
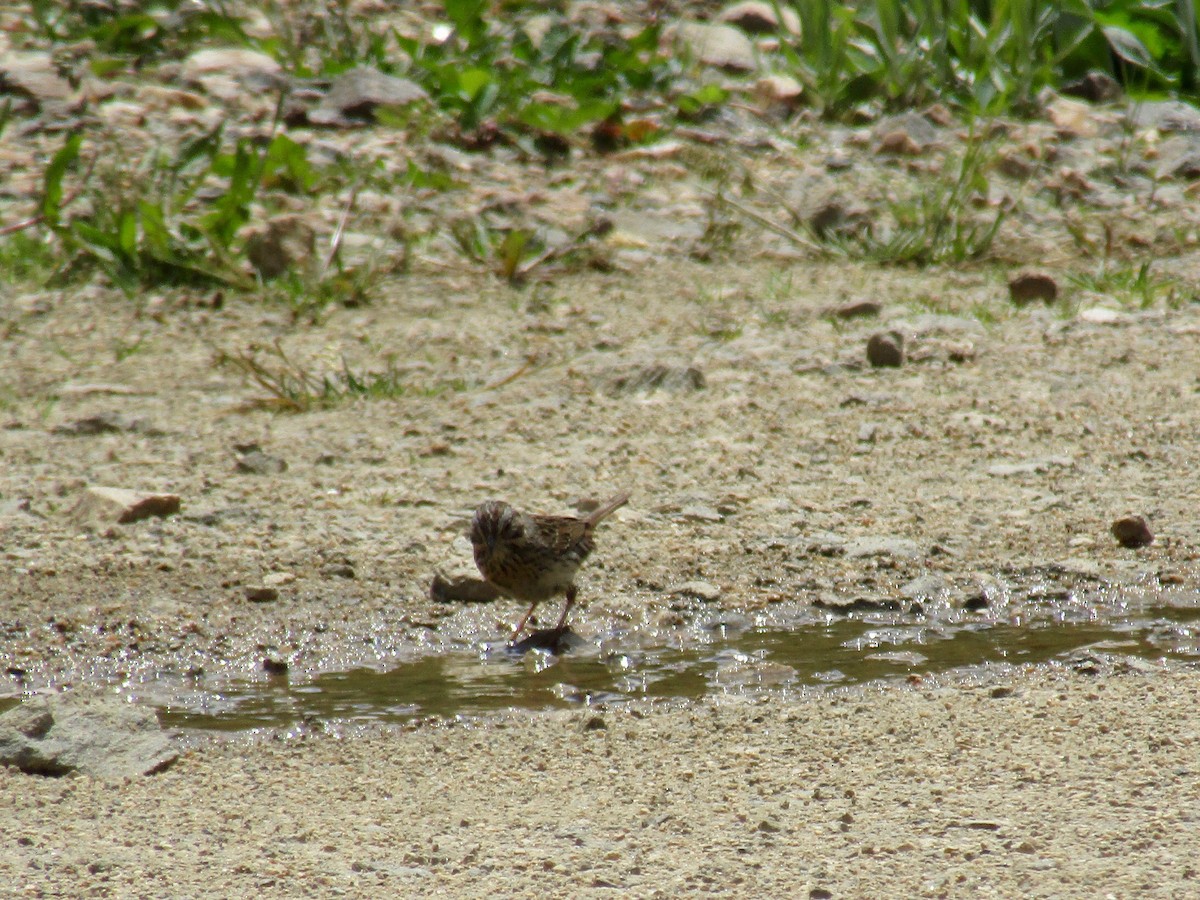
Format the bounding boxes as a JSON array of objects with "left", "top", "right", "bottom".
[{"left": 781, "top": 0, "right": 1200, "bottom": 115}]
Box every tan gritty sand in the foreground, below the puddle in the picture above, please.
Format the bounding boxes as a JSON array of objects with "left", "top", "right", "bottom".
[{"left": 0, "top": 670, "right": 1200, "bottom": 898}]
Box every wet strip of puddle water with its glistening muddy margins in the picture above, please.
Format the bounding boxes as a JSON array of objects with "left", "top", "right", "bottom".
[{"left": 7, "top": 593, "right": 1200, "bottom": 733}]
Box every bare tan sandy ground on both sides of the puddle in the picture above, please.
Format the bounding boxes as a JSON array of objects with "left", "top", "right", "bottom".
[{"left": 0, "top": 250, "right": 1200, "bottom": 896}]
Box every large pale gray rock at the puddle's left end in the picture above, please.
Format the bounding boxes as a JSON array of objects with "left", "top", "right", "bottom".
[{"left": 0, "top": 695, "right": 179, "bottom": 778}]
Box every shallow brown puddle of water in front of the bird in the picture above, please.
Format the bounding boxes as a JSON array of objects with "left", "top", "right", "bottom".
[{"left": 154, "top": 607, "right": 1200, "bottom": 731}]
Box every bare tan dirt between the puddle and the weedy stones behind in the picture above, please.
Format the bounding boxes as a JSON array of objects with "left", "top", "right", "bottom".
[{"left": 0, "top": 260, "right": 1200, "bottom": 690}]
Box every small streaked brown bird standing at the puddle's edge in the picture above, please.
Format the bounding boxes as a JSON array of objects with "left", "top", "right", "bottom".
[{"left": 470, "top": 493, "right": 629, "bottom": 640}]
